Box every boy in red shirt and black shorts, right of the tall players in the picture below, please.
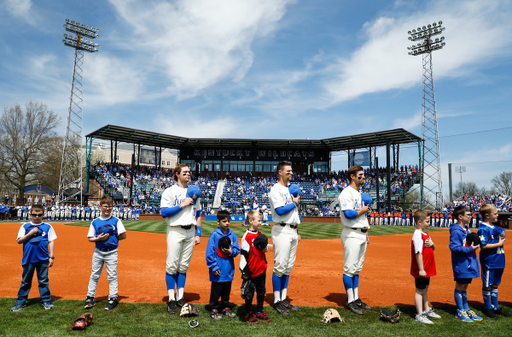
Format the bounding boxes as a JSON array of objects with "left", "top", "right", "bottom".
[{"left": 411, "top": 209, "right": 441, "bottom": 324}]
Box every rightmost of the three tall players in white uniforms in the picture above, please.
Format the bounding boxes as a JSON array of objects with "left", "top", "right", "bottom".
[{"left": 338, "top": 166, "right": 372, "bottom": 315}]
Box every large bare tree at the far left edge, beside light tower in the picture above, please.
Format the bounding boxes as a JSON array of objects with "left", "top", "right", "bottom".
[{"left": 0, "top": 102, "right": 62, "bottom": 203}]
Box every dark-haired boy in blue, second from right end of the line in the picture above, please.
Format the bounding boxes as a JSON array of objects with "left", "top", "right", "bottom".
[{"left": 448, "top": 206, "right": 482, "bottom": 323}]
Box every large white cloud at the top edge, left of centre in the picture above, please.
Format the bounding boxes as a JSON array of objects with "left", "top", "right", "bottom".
[{"left": 110, "top": 0, "right": 294, "bottom": 98}]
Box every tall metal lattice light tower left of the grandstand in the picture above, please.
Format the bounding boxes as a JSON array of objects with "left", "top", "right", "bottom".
[{"left": 59, "top": 19, "right": 99, "bottom": 204}]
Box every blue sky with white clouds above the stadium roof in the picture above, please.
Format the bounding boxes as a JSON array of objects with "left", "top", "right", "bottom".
[{"left": 0, "top": 0, "right": 512, "bottom": 197}]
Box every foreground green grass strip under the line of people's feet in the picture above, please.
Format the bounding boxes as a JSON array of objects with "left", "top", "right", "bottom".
[{"left": 0, "top": 298, "right": 512, "bottom": 337}]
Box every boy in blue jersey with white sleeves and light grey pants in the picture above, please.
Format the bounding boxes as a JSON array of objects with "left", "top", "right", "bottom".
[{"left": 84, "top": 196, "right": 126, "bottom": 311}]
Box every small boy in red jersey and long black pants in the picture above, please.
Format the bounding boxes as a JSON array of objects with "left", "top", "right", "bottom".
[{"left": 240, "top": 210, "right": 270, "bottom": 324}]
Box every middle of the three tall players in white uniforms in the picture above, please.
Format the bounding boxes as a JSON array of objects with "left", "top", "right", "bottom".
[{"left": 269, "top": 161, "right": 300, "bottom": 315}]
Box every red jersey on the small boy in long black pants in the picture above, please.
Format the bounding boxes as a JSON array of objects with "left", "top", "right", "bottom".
[{"left": 240, "top": 230, "right": 267, "bottom": 277}]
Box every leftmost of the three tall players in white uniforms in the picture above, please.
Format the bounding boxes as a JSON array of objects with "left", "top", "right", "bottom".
[{"left": 160, "top": 164, "right": 202, "bottom": 315}]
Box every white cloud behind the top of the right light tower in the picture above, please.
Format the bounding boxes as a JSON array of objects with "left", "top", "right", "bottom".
[{"left": 324, "top": 0, "right": 512, "bottom": 104}]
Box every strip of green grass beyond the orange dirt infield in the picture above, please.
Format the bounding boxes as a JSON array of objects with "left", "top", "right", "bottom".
[{"left": 63, "top": 220, "right": 447, "bottom": 239}]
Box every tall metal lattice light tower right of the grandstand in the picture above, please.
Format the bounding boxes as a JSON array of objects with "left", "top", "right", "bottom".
[{"left": 407, "top": 21, "right": 446, "bottom": 209}]
